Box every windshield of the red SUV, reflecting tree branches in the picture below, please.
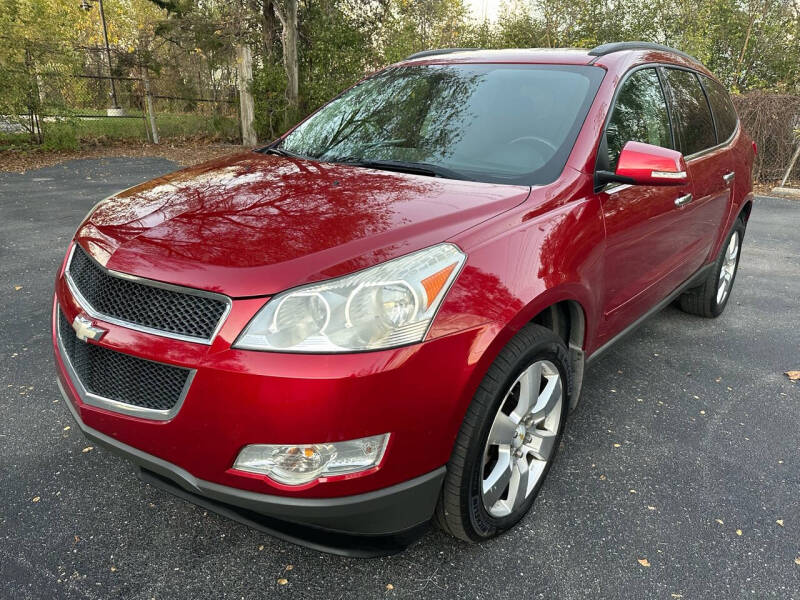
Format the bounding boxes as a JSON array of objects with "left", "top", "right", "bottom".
[{"left": 277, "top": 64, "right": 605, "bottom": 185}]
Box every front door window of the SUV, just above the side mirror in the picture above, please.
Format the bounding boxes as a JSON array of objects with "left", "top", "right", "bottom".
[{"left": 606, "top": 69, "right": 672, "bottom": 171}]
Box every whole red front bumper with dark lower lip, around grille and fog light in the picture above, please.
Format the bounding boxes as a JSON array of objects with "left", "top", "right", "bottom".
[{"left": 52, "top": 246, "right": 493, "bottom": 554}]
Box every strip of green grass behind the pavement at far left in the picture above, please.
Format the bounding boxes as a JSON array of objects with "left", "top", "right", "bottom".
[{"left": 0, "top": 111, "right": 239, "bottom": 151}]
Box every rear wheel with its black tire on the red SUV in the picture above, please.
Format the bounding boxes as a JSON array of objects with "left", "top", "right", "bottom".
[{"left": 678, "top": 218, "right": 745, "bottom": 319}]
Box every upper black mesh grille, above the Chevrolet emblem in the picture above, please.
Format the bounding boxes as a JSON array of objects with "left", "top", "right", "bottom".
[{"left": 67, "top": 244, "right": 228, "bottom": 341}]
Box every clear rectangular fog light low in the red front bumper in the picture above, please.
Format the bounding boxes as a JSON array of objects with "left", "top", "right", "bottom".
[{"left": 233, "top": 433, "right": 389, "bottom": 485}]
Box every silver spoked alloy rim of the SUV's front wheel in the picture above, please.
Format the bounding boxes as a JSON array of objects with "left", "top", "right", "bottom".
[{"left": 481, "top": 360, "right": 564, "bottom": 517}]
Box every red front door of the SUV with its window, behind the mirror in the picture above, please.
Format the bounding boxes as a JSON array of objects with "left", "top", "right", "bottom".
[{"left": 597, "top": 67, "right": 694, "bottom": 340}]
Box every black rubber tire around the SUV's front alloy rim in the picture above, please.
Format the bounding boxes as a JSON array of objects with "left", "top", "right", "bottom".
[{"left": 466, "top": 341, "right": 572, "bottom": 540}]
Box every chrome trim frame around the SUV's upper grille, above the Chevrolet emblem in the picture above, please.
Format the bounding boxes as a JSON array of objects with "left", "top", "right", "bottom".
[{"left": 64, "top": 242, "right": 232, "bottom": 345}]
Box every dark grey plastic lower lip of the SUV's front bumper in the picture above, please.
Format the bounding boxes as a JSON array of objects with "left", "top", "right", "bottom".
[{"left": 58, "top": 381, "right": 445, "bottom": 556}]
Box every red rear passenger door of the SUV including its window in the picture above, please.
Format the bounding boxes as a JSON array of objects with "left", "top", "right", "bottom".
[{"left": 663, "top": 67, "right": 733, "bottom": 270}]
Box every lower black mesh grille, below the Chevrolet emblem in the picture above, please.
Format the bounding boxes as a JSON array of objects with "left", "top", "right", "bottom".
[{"left": 58, "top": 309, "right": 191, "bottom": 410}]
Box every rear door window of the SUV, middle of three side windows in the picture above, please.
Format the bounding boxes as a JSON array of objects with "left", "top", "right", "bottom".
[{"left": 666, "top": 69, "right": 717, "bottom": 156}]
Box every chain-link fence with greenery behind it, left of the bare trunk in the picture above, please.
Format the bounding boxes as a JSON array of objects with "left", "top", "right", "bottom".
[{"left": 0, "top": 39, "right": 240, "bottom": 148}]
